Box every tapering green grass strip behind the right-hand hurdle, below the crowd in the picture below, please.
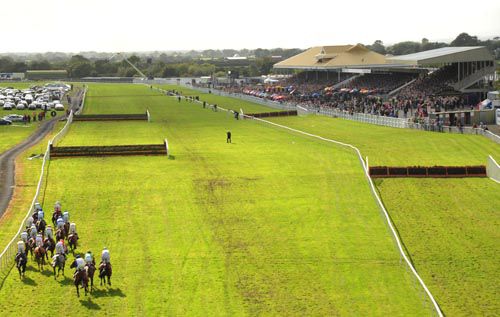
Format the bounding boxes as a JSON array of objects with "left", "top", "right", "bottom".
[{"left": 271, "top": 115, "right": 500, "bottom": 166}]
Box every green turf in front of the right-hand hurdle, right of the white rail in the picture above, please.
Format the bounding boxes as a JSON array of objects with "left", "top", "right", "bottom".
[{"left": 378, "top": 179, "right": 500, "bottom": 316}]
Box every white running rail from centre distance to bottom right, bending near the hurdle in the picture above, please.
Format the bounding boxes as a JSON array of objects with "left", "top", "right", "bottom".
[{"left": 151, "top": 87, "right": 443, "bottom": 317}]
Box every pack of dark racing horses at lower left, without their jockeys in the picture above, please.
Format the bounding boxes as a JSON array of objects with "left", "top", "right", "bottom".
[{"left": 15, "top": 205, "right": 112, "bottom": 297}]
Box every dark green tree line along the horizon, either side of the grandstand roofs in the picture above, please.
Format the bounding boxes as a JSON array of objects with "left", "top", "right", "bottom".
[{"left": 0, "top": 33, "right": 500, "bottom": 78}]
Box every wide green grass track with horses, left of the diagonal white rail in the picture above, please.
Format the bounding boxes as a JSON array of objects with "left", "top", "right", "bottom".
[{"left": 0, "top": 84, "right": 431, "bottom": 316}]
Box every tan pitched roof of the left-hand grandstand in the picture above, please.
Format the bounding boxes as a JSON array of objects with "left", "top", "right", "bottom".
[{"left": 274, "top": 44, "right": 386, "bottom": 70}]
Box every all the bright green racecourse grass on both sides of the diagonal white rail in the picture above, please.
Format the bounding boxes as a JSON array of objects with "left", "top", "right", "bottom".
[{"left": 0, "top": 84, "right": 500, "bottom": 316}]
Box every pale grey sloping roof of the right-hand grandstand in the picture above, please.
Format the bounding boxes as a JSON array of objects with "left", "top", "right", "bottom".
[{"left": 387, "top": 46, "right": 494, "bottom": 66}]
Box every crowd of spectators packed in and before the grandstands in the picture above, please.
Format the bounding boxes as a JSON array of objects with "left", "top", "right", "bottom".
[{"left": 221, "top": 66, "right": 479, "bottom": 121}]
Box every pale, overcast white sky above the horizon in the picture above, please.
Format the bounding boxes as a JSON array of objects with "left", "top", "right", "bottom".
[{"left": 0, "top": 0, "right": 500, "bottom": 53}]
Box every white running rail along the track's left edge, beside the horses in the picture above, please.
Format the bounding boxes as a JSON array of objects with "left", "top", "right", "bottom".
[{"left": 0, "top": 110, "right": 73, "bottom": 272}]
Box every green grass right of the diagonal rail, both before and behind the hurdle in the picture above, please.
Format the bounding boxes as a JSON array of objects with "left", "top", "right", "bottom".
[{"left": 272, "top": 115, "right": 500, "bottom": 316}]
